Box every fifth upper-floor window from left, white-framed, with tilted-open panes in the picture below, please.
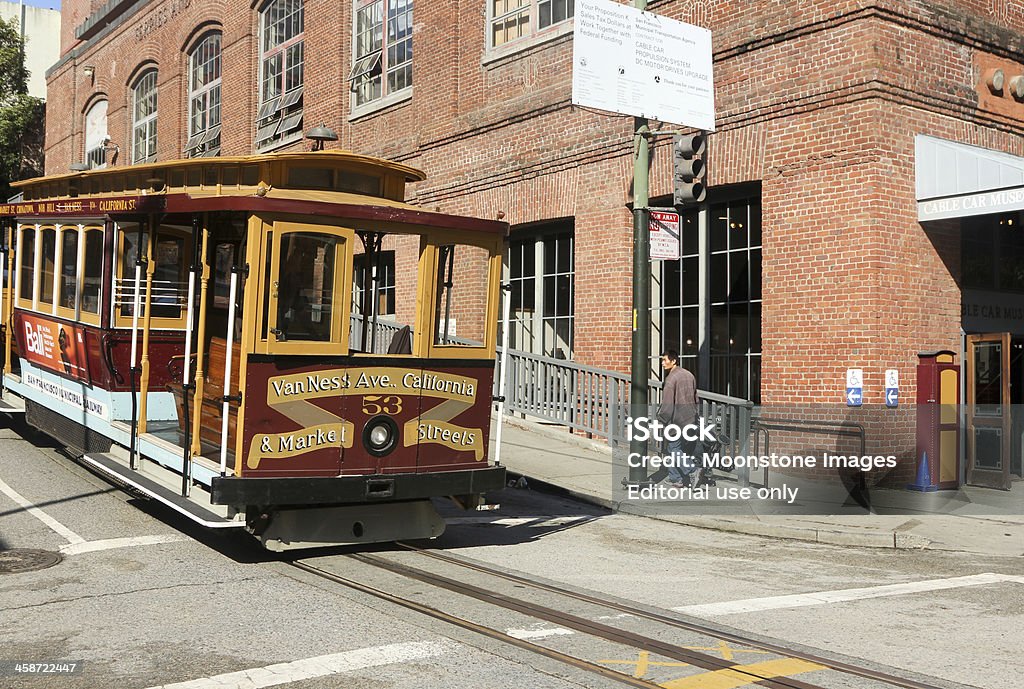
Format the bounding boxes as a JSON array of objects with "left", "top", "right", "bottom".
[{"left": 348, "top": 0, "right": 415, "bottom": 117}]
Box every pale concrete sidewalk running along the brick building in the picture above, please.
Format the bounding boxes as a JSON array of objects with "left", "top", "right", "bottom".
[{"left": 490, "top": 417, "right": 1024, "bottom": 556}]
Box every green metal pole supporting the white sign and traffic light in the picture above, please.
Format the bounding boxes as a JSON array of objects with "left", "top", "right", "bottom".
[{"left": 629, "top": 0, "right": 650, "bottom": 483}]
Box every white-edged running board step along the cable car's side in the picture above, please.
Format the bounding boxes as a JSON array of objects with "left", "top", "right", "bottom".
[{"left": 82, "top": 453, "right": 246, "bottom": 528}]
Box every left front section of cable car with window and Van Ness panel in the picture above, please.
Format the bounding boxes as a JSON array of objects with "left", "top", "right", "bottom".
[{"left": 241, "top": 220, "right": 354, "bottom": 476}]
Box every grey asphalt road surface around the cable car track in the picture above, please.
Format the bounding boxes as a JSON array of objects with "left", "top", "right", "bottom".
[{"left": 0, "top": 419, "right": 1024, "bottom": 689}]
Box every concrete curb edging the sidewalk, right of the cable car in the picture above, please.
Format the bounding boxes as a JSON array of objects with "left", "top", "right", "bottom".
[{"left": 506, "top": 467, "right": 932, "bottom": 550}]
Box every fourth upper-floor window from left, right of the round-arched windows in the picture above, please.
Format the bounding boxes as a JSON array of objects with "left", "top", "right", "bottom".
[{"left": 256, "top": 0, "right": 305, "bottom": 150}]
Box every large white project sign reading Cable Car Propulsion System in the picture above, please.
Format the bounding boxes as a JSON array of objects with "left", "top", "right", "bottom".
[{"left": 572, "top": 0, "right": 715, "bottom": 131}]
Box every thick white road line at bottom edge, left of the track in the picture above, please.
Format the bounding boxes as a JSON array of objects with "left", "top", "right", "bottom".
[{"left": 150, "top": 641, "right": 450, "bottom": 689}]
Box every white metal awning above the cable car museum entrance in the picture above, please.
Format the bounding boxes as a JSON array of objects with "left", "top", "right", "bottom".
[{"left": 914, "top": 134, "right": 1024, "bottom": 221}]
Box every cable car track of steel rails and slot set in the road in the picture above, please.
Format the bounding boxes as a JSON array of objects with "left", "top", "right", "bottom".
[{"left": 289, "top": 544, "right": 943, "bottom": 689}]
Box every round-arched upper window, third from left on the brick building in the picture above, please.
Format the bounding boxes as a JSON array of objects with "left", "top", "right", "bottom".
[{"left": 184, "top": 33, "right": 220, "bottom": 158}]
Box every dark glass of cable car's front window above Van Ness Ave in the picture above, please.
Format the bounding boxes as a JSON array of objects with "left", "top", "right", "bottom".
[{"left": 274, "top": 232, "right": 342, "bottom": 342}]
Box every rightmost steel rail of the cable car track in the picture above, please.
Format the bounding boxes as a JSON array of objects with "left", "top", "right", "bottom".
[{"left": 393, "top": 543, "right": 944, "bottom": 689}]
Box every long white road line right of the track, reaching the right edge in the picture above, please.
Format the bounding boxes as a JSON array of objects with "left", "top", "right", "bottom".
[{"left": 672, "top": 573, "right": 1024, "bottom": 617}]
